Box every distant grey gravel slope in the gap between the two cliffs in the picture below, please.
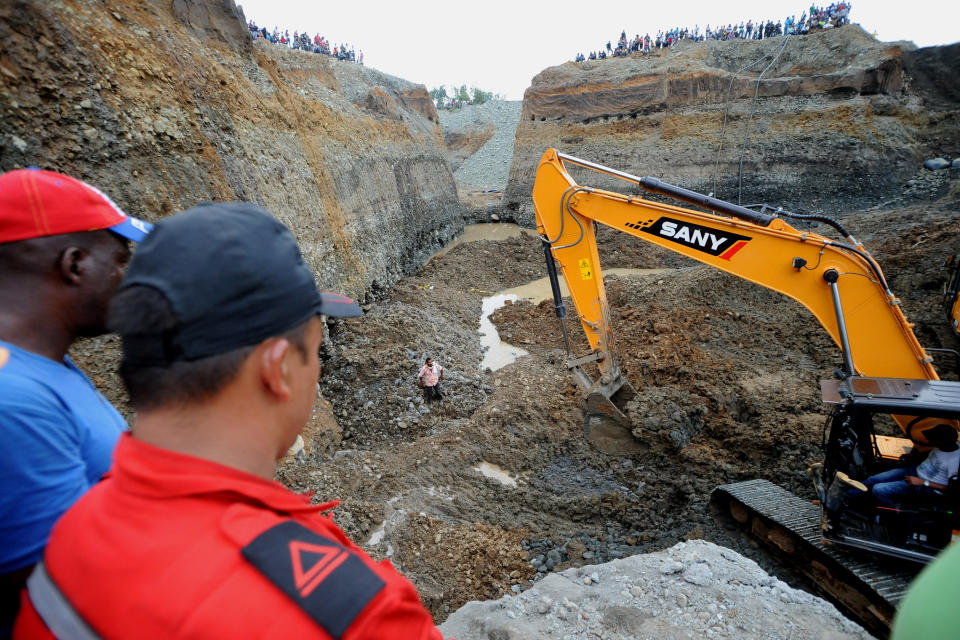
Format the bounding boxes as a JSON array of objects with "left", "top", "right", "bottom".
[{"left": 439, "top": 100, "right": 523, "bottom": 190}]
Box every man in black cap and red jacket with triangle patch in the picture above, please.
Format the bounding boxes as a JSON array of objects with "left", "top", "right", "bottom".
[{"left": 14, "top": 204, "right": 440, "bottom": 640}]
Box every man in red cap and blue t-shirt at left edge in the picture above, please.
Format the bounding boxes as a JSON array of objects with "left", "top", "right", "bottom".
[{"left": 0, "top": 169, "right": 150, "bottom": 638}]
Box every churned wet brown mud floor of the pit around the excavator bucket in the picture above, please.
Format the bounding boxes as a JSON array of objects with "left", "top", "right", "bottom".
[{"left": 279, "top": 192, "right": 960, "bottom": 621}]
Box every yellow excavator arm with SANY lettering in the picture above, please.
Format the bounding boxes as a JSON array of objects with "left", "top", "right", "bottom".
[{"left": 533, "top": 149, "right": 938, "bottom": 438}]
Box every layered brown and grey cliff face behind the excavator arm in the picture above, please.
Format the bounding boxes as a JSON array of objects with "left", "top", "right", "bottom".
[{"left": 504, "top": 26, "right": 960, "bottom": 225}]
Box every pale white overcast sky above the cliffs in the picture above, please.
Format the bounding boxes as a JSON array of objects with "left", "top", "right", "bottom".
[{"left": 236, "top": 0, "right": 960, "bottom": 100}]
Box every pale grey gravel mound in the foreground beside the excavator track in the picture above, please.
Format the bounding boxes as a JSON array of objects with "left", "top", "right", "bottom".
[{"left": 440, "top": 540, "right": 871, "bottom": 640}]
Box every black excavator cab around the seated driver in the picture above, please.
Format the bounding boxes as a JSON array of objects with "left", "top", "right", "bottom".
[{"left": 815, "top": 376, "right": 960, "bottom": 563}]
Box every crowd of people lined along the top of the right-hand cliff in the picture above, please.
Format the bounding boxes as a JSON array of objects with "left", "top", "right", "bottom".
[{"left": 574, "top": 0, "right": 850, "bottom": 62}]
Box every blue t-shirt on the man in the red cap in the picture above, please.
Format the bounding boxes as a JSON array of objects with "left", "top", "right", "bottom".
[{"left": 0, "top": 340, "right": 127, "bottom": 573}]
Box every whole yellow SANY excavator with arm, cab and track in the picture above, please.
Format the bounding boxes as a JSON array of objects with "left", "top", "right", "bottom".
[{"left": 533, "top": 149, "right": 960, "bottom": 635}]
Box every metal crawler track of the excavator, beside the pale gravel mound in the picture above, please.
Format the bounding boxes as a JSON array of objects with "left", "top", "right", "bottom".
[{"left": 710, "top": 479, "right": 920, "bottom": 638}]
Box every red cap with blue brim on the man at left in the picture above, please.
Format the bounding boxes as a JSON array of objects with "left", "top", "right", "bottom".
[{"left": 0, "top": 169, "right": 153, "bottom": 243}]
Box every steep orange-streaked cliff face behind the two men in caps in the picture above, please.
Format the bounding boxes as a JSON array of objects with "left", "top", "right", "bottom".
[{"left": 0, "top": 0, "right": 462, "bottom": 299}]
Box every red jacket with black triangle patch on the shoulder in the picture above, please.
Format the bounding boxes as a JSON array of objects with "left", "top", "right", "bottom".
[{"left": 14, "top": 434, "right": 442, "bottom": 640}]
